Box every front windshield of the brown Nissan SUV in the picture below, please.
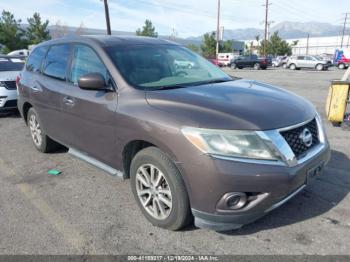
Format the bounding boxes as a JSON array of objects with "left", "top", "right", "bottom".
[{"left": 107, "top": 45, "right": 232, "bottom": 89}]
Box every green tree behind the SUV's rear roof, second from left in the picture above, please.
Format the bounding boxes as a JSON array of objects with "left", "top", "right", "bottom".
[{"left": 26, "top": 13, "right": 51, "bottom": 45}]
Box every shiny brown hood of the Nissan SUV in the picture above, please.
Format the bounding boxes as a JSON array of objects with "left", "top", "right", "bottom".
[{"left": 146, "top": 79, "right": 316, "bottom": 130}]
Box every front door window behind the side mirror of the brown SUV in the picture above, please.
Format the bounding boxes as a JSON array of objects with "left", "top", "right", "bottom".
[{"left": 70, "top": 45, "right": 108, "bottom": 84}]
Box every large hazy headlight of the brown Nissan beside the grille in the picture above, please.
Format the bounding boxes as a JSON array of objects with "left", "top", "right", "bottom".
[{"left": 181, "top": 127, "right": 281, "bottom": 160}]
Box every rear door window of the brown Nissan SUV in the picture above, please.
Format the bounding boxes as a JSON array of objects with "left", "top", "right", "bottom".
[{"left": 43, "top": 44, "right": 70, "bottom": 80}]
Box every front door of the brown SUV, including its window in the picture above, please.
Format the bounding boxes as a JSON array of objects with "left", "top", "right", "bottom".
[{"left": 62, "top": 44, "right": 118, "bottom": 165}]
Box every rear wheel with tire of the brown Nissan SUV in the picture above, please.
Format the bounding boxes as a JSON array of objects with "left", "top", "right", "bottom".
[{"left": 27, "top": 107, "right": 59, "bottom": 153}]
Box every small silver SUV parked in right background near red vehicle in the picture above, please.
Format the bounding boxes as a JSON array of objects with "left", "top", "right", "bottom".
[{"left": 287, "top": 55, "right": 330, "bottom": 71}]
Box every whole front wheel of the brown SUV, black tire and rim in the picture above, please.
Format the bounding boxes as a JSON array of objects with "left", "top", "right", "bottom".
[{"left": 130, "top": 147, "right": 192, "bottom": 230}]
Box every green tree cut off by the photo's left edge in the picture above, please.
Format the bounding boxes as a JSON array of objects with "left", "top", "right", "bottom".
[{"left": 0, "top": 10, "right": 26, "bottom": 52}]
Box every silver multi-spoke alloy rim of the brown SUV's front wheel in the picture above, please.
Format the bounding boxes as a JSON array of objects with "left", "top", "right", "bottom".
[{"left": 135, "top": 164, "right": 173, "bottom": 220}]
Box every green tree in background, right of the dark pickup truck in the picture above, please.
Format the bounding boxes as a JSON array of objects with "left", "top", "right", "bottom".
[{"left": 259, "top": 32, "right": 292, "bottom": 55}]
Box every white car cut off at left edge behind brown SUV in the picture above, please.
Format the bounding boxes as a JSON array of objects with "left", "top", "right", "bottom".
[{"left": 0, "top": 56, "right": 24, "bottom": 111}]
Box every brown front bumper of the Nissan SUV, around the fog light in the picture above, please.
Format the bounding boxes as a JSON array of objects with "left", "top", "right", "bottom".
[{"left": 187, "top": 143, "right": 330, "bottom": 231}]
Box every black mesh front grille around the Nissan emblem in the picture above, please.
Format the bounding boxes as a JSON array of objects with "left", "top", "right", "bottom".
[{"left": 281, "top": 119, "right": 320, "bottom": 159}]
